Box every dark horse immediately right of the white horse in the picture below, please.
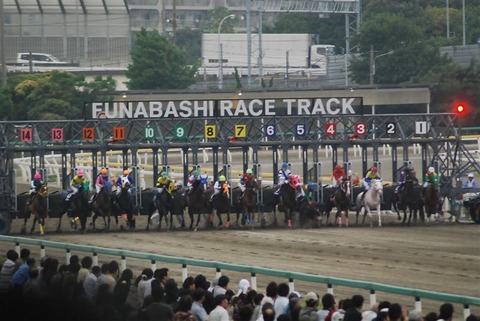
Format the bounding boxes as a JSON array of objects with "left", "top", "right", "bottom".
[{"left": 392, "top": 171, "right": 420, "bottom": 225}]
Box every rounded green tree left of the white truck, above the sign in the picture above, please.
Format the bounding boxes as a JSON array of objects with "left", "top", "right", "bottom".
[{"left": 125, "top": 28, "right": 199, "bottom": 89}]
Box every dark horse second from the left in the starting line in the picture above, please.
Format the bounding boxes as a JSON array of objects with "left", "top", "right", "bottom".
[{"left": 57, "top": 182, "right": 91, "bottom": 233}]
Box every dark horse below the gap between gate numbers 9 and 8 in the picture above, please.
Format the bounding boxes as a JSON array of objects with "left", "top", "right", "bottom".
[{"left": 187, "top": 177, "right": 211, "bottom": 231}]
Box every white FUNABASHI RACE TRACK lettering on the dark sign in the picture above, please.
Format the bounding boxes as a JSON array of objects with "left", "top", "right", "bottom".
[{"left": 89, "top": 97, "right": 362, "bottom": 119}]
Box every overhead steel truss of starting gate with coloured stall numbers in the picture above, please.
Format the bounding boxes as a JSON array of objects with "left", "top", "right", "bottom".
[{"left": 0, "top": 110, "right": 480, "bottom": 215}]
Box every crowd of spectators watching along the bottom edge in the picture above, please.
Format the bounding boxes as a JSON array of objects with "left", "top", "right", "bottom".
[{"left": 0, "top": 248, "right": 479, "bottom": 321}]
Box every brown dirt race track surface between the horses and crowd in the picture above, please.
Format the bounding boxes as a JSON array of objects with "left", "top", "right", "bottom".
[{"left": 0, "top": 215, "right": 480, "bottom": 320}]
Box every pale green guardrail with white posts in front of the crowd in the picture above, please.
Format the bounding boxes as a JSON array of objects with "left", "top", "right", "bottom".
[{"left": 0, "top": 235, "right": 480, "bottom": 319}]
